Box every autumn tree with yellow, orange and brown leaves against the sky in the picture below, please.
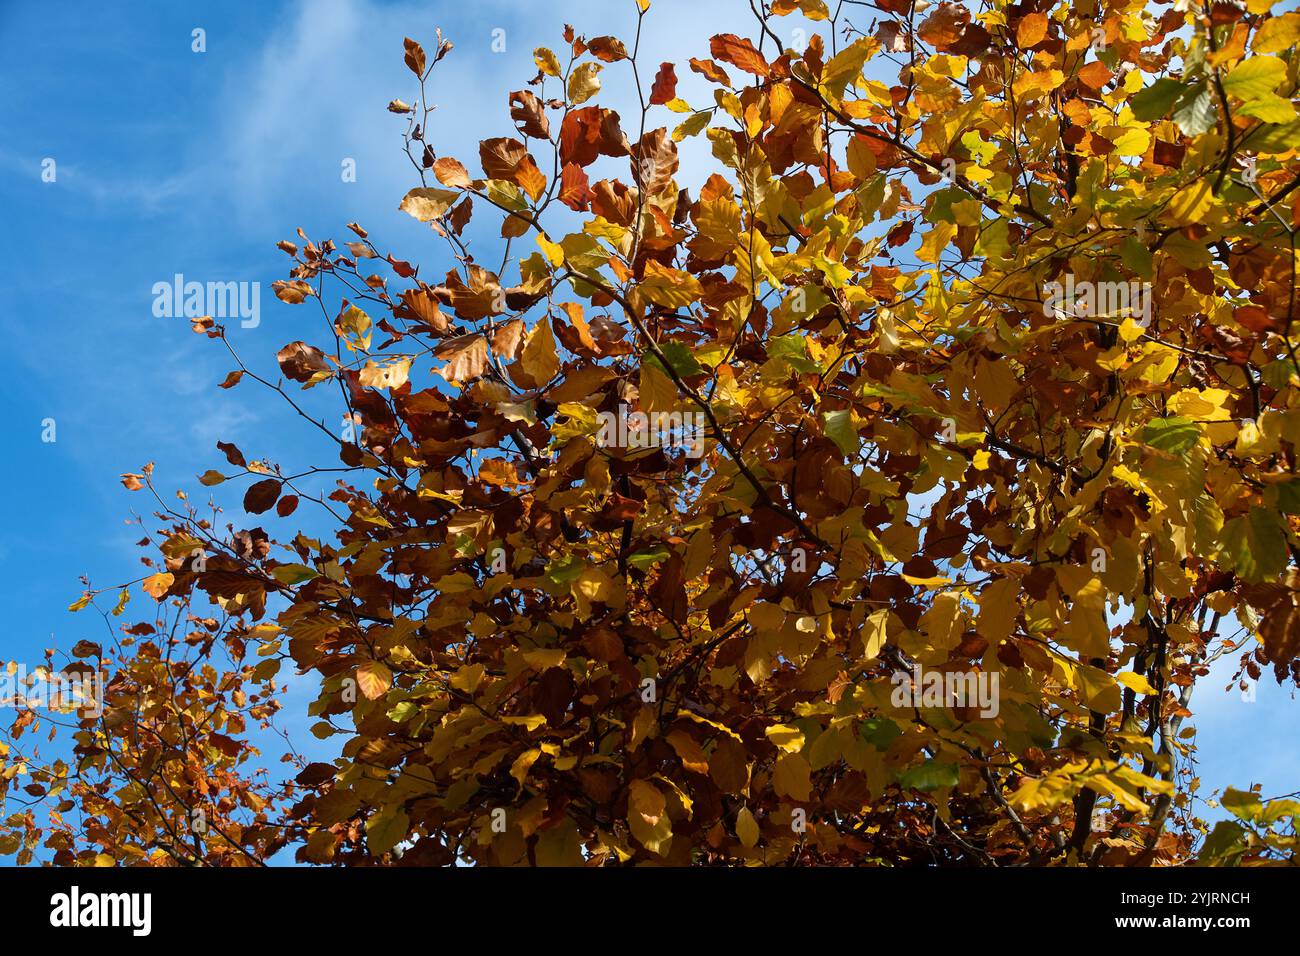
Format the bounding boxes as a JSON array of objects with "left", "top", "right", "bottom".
[{"left": 3, "top": 0, "right": 1300, "bottom": 865}]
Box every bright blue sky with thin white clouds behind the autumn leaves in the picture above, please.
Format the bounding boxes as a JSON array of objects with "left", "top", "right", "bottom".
[{"left": 0, "top": 0, "right": 1300, "bottom": 853}]
